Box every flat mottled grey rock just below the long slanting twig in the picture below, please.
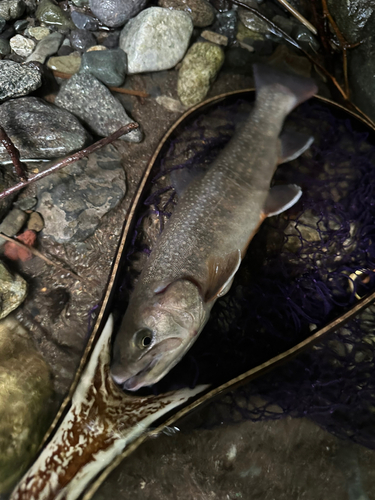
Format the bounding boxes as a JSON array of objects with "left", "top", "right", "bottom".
[{"left": 37, "top": 145, "right": 126, "bottom": 243}]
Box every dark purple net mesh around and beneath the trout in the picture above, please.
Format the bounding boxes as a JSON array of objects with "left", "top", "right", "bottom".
[{"left": 114, "top": 98, "right": 375, "bottom": 448}]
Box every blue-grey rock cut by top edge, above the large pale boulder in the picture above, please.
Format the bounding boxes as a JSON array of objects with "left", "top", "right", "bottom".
[{"left": 89, "top": 0, "right": 147, "bottom": 28}]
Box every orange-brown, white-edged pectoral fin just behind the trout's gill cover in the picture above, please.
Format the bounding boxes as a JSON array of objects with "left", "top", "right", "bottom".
[{"left": 204, "top": 250, "right": 241, "bottom": 302}]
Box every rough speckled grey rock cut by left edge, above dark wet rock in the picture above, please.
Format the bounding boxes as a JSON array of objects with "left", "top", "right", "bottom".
[{"left": 0, "top": 60, "right": 42, "bottom": 102}]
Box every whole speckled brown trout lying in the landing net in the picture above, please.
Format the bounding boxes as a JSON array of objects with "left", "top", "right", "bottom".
[{"left": 110, "top": 64, "right": 317, "bottom": 391}]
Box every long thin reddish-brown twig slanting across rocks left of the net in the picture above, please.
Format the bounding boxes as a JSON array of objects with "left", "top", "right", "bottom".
[{"left": 0, "top": 123, "right": 139, "bottom": 200}]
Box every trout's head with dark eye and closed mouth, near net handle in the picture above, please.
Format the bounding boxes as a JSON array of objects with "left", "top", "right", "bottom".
[{"left": 111, "top": 279, "right": 209, "bottom": 391}]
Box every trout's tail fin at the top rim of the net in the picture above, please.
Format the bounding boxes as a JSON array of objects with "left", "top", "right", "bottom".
[{"left": 253, "top": 64, "right": 318, "bottom": 109}]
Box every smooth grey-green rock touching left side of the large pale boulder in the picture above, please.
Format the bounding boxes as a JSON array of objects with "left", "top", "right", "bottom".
[{"left": 80, "top": 49, "right": 127, "bottom": 87}]
